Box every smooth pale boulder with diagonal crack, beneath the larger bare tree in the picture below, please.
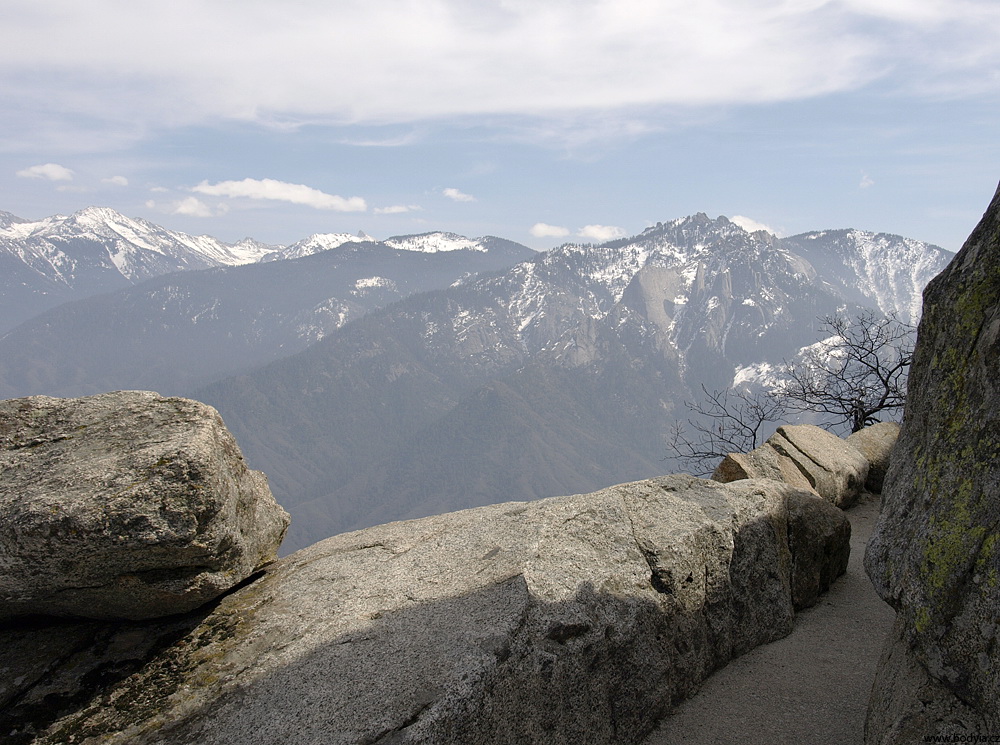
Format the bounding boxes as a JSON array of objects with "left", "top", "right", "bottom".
[{"left": 767, "top": 424, "right": 868, "bottom": 508}]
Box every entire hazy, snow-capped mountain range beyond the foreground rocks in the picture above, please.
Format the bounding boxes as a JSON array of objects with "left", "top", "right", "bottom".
[{"left": 0, "top": 210, "right": 951, "bottom": 549}]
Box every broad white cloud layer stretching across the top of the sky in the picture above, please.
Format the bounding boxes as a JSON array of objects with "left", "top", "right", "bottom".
[{"left": 7, "top": 0, "right": 1000, "bottom": 143}]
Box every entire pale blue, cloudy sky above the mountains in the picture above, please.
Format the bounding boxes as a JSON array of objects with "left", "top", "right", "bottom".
[{"left": 0, "top": 0, "right": 1000, "bottom": 251}]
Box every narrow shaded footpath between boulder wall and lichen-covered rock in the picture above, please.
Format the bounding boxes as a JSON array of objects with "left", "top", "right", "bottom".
[{"left": 644, "top": 497, "right": 894, "bottom": 745}]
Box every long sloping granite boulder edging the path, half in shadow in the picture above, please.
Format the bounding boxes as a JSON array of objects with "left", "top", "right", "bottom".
[{"left": 0, "top": 476, "right": 849, "bottom": 745}]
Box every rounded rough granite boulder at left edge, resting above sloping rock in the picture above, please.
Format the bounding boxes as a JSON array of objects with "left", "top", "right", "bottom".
[{"left": 0, "top": 391, "right": 288, "bottom": 619}]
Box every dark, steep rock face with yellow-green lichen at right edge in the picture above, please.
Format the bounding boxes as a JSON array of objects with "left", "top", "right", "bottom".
[{"left": 865, "top": 183, "right": 1000, "bottom": 744}]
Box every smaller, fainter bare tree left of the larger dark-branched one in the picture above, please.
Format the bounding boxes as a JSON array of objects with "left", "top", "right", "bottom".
[{"left": 667, "top": 385, "right": 786, "bottom": 475}]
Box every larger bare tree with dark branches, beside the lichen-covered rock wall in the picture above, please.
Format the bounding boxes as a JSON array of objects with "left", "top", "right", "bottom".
[{"left": 777, "top": 311, "right": 915, "bottom": 432}]
